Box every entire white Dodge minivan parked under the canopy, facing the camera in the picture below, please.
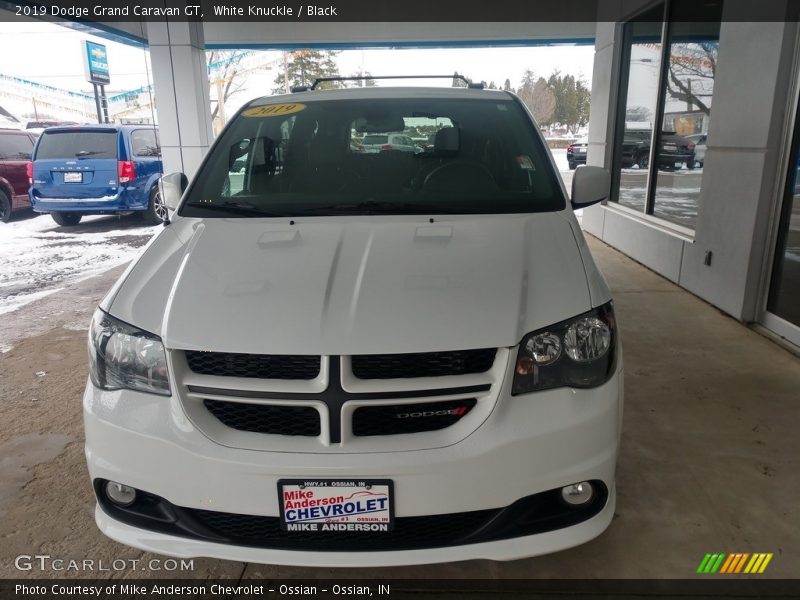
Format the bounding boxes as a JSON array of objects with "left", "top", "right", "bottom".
[{"left": 84, "top": 88, "right": 622, "bottom": 566}]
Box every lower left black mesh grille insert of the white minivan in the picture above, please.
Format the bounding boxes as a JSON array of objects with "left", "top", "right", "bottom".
[{"left": 203, "top": 400, "right": 320, "bottom": 437}]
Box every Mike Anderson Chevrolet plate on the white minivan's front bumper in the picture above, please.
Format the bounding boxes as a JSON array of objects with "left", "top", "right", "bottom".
[{"left": 278, "top": 479, "right": 394, "bottom": 533}]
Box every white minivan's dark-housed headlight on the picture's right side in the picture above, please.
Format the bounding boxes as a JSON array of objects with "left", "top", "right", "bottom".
[{"left": 511, "top": 302, "right": 617, "bottom": 396}]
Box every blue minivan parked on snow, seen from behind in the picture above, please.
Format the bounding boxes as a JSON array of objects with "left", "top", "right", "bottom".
[{"left": 28, "top": 125, "right": 167, "bottom": 226}]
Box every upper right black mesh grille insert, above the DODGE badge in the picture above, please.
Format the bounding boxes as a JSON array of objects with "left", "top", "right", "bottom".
[{"left": 351, "top": 348, "right": 497, "bottom": 379}]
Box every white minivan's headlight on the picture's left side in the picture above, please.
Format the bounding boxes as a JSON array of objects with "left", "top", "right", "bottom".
[{"left": 89, "top": 309, "right": 170, "bottom": 396}]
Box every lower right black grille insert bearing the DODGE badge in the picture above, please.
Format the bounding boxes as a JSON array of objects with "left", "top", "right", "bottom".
[{"left": 353, "top": 398, "right": 476, "bottom": 436}]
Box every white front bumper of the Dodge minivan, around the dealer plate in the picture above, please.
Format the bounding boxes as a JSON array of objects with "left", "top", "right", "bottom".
[{"left": 84, "top": 364, "right": 622, "bottom": 566}]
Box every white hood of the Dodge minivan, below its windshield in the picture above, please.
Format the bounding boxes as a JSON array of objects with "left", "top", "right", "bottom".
[{"left": 104, "top": 213, "right": 591, "bottom": 354}]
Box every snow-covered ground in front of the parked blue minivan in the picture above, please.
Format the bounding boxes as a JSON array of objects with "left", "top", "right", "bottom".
[{"left": 0, "top": 213, "right": 158, "bottom": 314}]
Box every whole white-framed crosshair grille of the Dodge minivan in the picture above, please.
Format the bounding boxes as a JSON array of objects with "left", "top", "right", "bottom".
[{"left": 184, "top": 348, "right": 509, "bottom": 442}]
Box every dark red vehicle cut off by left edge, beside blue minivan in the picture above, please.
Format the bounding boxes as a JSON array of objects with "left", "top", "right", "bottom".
[{"left": 0, "top": 129, "right": 36, "bottom": 223}]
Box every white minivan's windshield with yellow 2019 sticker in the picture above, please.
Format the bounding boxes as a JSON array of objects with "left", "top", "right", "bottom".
[{"left": 180, "top": 97, "right": 565, "bottom": 217}]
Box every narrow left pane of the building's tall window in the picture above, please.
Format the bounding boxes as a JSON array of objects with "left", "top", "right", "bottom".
[{"left": 617, "top": 11, "right": 663, "bottom": 211}]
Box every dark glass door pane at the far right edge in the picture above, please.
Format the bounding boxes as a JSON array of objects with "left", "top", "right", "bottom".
[{"left": 767, "top": 141, "right": 800, "bottom": 326}]
